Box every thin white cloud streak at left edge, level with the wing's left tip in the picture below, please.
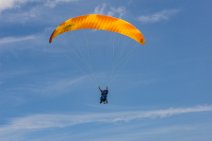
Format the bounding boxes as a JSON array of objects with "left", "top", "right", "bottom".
[{"left": 0, "top": 35, "right": 36, "bottom": 45}]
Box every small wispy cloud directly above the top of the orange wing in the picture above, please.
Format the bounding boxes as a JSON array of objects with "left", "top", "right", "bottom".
[{"left": 94, "top": 3, "right": 126, "bottom": 17}]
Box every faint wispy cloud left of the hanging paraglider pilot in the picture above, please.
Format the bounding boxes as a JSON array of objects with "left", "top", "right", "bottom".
[{"left": 3, "top": 73, "right": 89, "bottom": 97}]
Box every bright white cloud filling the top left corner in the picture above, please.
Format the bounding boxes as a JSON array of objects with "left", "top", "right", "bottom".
[{"left": 0, "top": 0, "right": 27, "bottom": 12}]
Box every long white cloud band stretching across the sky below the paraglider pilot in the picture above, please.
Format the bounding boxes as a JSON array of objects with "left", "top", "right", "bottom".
[{"left": 0, "top": 105, "right": 212, "bottom": 131}]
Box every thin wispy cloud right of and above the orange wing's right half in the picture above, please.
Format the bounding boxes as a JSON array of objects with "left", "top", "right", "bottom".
[{"left": 138, "top": 9, "right": 179, "bottom": 23}]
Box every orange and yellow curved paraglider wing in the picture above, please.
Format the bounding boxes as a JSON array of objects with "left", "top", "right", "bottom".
[{"left": 49, "top": 14, "right": 145, "bottom": 44}]
